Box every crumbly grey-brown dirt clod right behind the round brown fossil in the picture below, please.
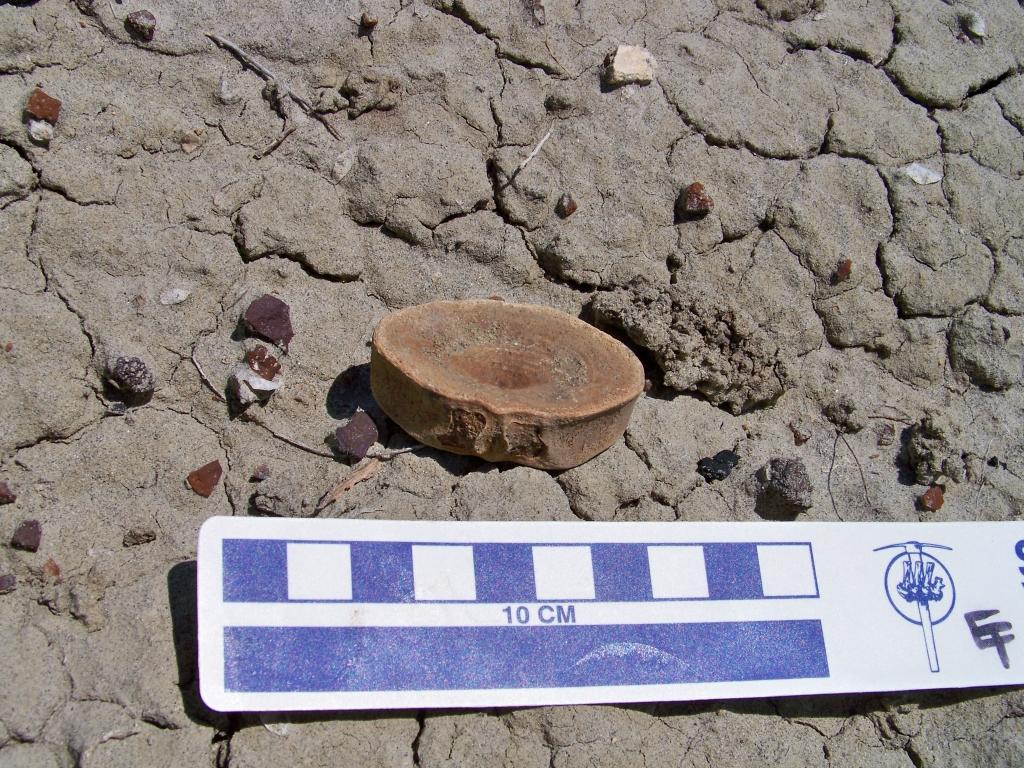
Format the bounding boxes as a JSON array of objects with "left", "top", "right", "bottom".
[{"left": 593, "top": 284, "right": 791, "bottom": 414}]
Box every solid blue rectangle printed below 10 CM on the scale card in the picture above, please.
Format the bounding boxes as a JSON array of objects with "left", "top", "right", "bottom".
[{"left": 224, "top": 620, "right": 828, "bottom": 693}]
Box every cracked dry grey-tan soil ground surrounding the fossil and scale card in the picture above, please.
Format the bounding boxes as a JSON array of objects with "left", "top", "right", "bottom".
[{"left": 0, "top": 0, "right": 1024, "bottom": 768}]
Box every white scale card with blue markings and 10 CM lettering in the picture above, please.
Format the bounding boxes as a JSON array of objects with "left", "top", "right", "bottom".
[{"left": 193, "top": 517, "right": 1024, "bottom": 711}]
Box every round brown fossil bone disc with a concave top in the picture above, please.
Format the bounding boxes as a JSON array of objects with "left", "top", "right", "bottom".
[{"left": 370, "top": 300, "right": 644, "bottom": 469}]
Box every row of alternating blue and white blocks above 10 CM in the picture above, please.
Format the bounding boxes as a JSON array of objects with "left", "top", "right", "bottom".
[{"left": 222, "top": 539, "right": 818, "bottom": 603}]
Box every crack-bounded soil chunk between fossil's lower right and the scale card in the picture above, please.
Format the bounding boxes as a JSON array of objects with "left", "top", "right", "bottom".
[{"left": 558, "top": 440, "right": 654, "bottom": 521}]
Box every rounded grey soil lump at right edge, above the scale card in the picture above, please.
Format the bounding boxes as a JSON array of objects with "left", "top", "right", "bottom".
[{"left": 949, "top": 304, "right": 1024, "bottom": 389}]
